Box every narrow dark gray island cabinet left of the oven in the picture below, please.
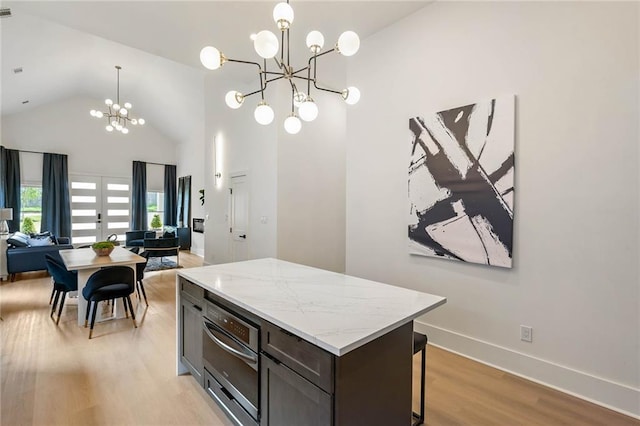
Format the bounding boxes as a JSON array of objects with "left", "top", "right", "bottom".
[{"left": 180, "top": 279, "right": 204, "bottom": 386}]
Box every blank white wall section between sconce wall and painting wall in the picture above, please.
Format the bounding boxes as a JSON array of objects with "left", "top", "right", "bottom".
[{"left": 275, "top": 55, "right": 350, "bottom": 272}]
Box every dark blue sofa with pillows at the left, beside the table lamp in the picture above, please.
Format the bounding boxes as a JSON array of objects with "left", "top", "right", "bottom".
[{"left": 7, "top": 233, "right": 73, "bottom": 281}]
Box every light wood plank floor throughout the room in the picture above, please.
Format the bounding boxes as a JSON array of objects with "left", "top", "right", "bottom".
[{"left": 0, "top": 253, "right": 640, "bottom": 426}]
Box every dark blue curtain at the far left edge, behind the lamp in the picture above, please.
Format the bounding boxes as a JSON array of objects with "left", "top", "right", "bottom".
[{"left": 0, "top": 146, "right": 20, "bottom": 232}]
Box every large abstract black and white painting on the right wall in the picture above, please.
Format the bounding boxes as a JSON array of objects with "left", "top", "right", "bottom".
[{"left": 409, "top": 95, "right": 515, "bottom": 268}]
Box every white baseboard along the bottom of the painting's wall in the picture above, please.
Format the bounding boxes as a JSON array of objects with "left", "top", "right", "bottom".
[{"left": 414, "top": 321, "right": 640, "bottom": 419}]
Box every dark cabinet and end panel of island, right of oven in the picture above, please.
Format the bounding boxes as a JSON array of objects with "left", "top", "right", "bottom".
[{"left": 260, "top": 321, "right": 413, "bottom": 426}]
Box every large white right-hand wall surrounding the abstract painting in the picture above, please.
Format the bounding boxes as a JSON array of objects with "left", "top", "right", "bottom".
[{"left": 346, "top": 2, "right": 640, "bottom": 416}]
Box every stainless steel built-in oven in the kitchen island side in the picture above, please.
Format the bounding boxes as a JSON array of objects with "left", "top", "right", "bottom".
[{"left": 202, "top": 302, "right": 260, "bottom": 425}]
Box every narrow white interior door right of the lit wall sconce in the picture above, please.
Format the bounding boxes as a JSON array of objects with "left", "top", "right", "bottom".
[{"left": 229, "top": 175, "right": 249, "bottom": 262}]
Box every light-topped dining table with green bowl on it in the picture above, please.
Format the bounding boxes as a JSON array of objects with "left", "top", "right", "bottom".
[{"left": 60, "top": 246, "right": 146, "bottom": 326}]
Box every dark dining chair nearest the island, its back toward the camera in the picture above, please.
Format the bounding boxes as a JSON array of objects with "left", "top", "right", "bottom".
[{"left": 82, "top": 266, "right": 138, "bottom": 339}]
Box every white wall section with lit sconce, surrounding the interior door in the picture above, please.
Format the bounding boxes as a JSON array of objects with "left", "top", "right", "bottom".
[{"left": 204, "top": 75, "right": 277, "bottom": 264}]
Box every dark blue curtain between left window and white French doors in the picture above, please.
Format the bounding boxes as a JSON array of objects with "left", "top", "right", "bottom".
[{"left": 40, "top": 153, "right": 71, "bottom": 237}]
